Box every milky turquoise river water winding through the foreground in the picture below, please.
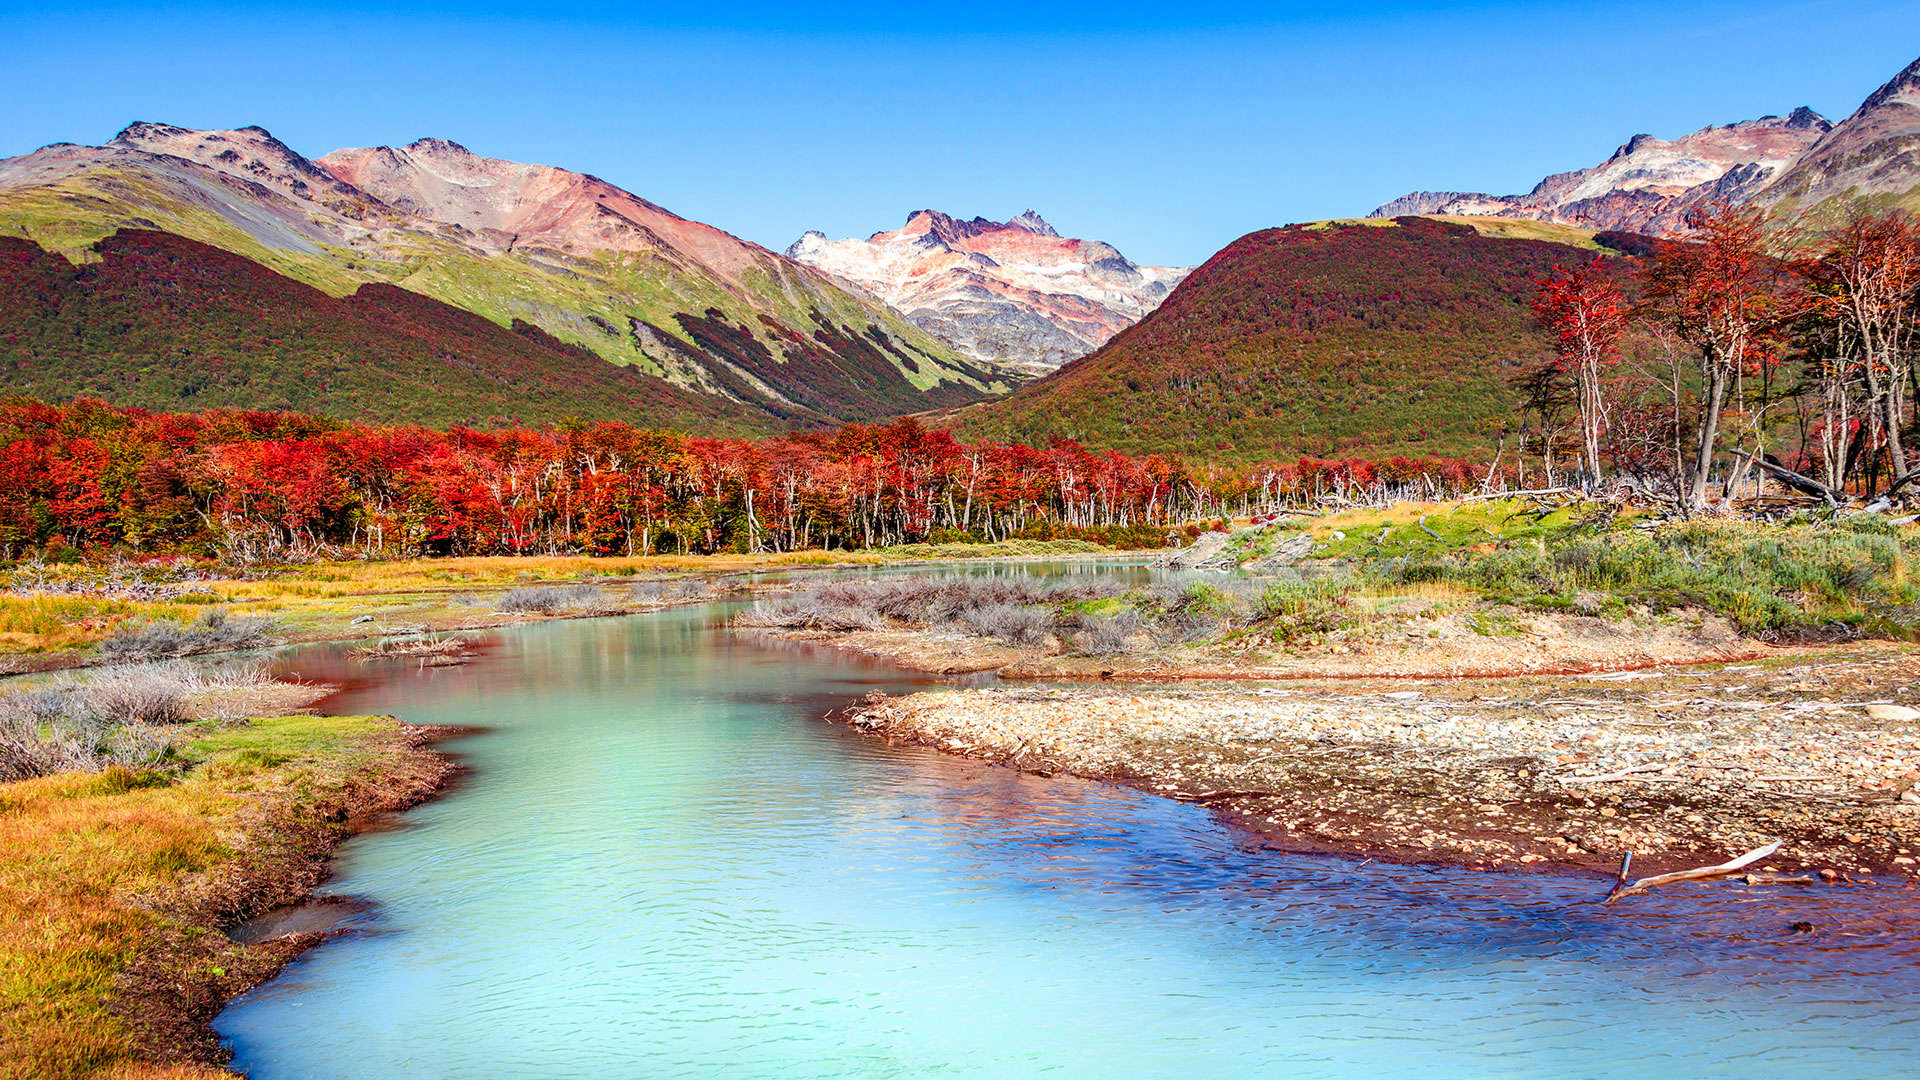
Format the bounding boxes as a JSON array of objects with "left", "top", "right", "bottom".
[{"left": 215, "top": 564, "right": 1920, "bottom": 1080}]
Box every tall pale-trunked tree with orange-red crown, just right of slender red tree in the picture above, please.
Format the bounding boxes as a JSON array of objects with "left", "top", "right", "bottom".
[{"left": 1644, "top": 204, "right": 1786, "bottom": 507}]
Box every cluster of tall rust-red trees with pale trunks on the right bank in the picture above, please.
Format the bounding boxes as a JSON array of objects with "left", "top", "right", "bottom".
[{"left": 1513, "top": 204, "right": 1920, "bottom": 509}]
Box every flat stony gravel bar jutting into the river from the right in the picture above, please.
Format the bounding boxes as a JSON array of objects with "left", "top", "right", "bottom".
[{"left": 847, "top": 646, "right": 1920, "bottom": 884}]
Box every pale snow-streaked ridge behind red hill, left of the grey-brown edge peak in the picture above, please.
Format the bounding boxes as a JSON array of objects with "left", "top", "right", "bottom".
[{"left": 1373, "top": 108, "right": 1832, "bottom": 234}]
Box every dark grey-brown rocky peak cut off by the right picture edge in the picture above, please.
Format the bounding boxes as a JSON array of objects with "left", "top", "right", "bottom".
[{"left": 1759, "top": 60, "right": 1920, "bottom": 221}]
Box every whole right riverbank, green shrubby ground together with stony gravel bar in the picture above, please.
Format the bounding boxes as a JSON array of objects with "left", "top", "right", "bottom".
[{"left": 718, "top": 502, "right": 1920, "bottom": 882}]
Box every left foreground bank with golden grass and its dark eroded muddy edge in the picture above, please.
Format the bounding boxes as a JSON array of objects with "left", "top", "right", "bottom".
[{"left": 0, "top": 715, "right": 457, "bottom": 1080}]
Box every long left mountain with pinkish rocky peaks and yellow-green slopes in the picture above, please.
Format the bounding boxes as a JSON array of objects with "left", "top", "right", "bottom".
[{"left": 0, "top": 123, "right": 1008, "bottom": 423}]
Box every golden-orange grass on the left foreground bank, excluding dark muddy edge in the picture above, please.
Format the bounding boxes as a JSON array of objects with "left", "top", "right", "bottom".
[{"left": 0, "top": 717, "right": 396, "bottom": 1080}]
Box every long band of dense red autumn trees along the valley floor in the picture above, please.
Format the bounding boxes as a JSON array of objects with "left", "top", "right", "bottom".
[{"left": 0, "top": 398, "right": 1475, "bottom": 561}]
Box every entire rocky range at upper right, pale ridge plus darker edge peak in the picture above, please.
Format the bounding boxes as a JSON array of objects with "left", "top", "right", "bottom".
[{"left": 1373, "top": 60, "right": 1920, "bottom": 236}]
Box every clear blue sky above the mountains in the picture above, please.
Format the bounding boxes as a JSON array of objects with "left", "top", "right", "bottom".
[{"left": 0, "top": 0, "right": 1920, "bottom": 263}]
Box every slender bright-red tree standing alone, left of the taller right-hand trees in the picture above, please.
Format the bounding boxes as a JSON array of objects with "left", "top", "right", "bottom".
[{"left": 1534, "top": 259, "right": 1626, "bottom": 490}]
